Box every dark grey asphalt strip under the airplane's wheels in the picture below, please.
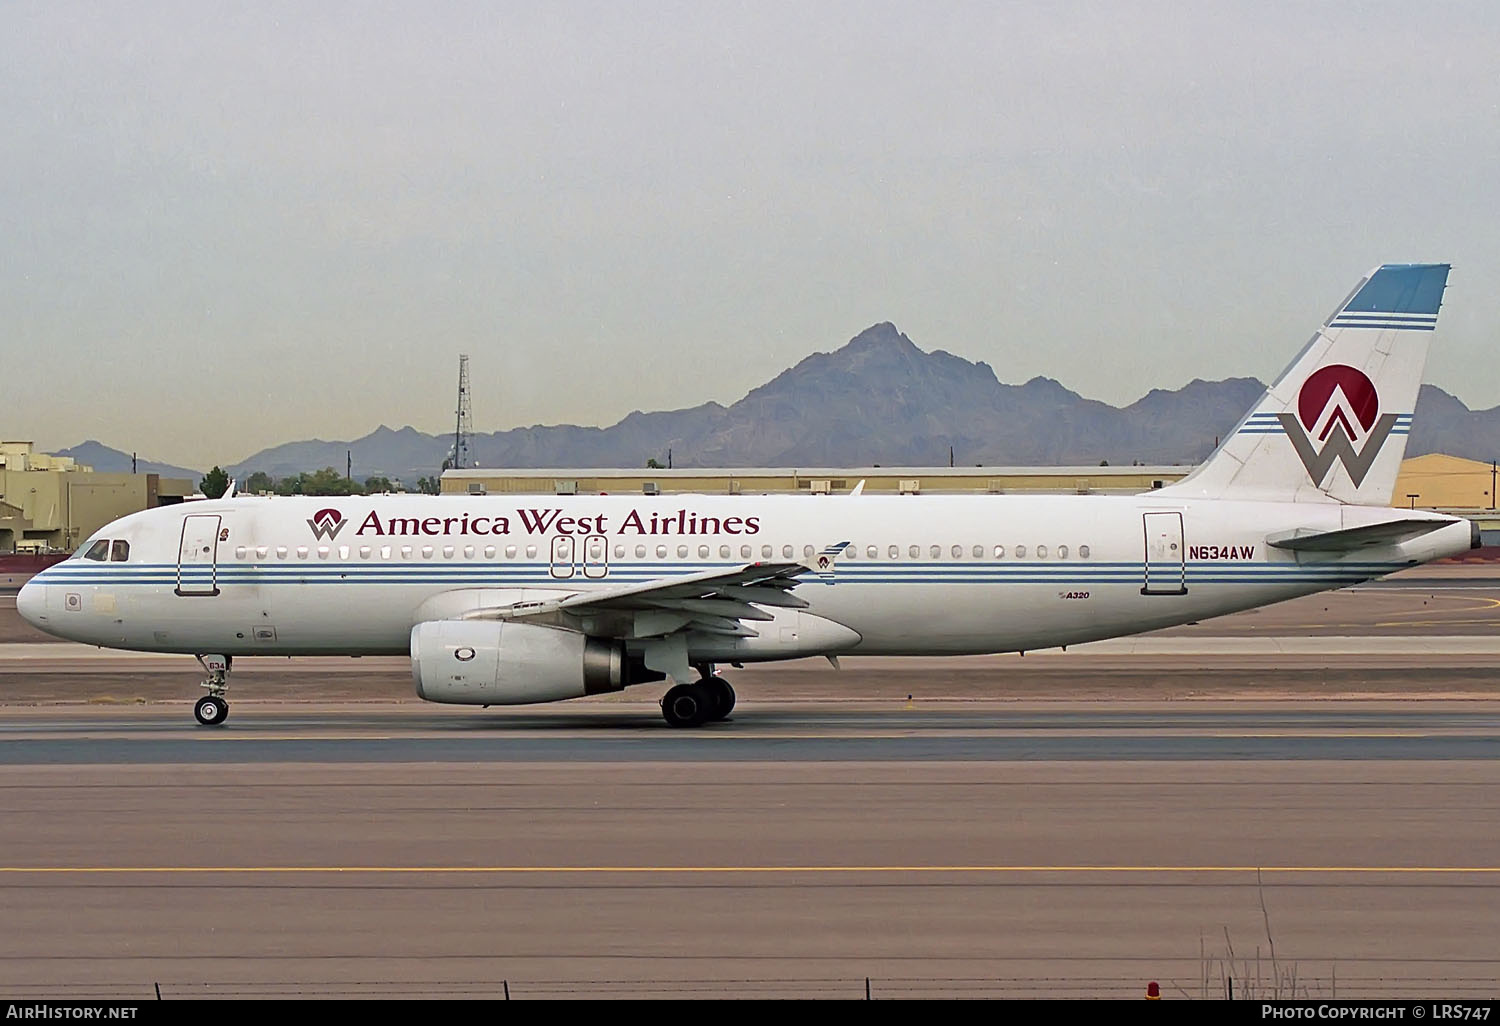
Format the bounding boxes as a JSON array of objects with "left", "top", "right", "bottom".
[{"left": 0, "top": 702, "right": 1500, "bottom": 767}]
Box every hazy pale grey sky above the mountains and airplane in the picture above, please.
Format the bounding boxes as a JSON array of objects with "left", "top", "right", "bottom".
[{"left": 0, "top": 0, "right": 1500, "bottom": 467}]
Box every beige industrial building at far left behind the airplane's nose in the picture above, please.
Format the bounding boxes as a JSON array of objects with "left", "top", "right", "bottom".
[{"left": 0, "top": 441, "right": 194, "bottom": 554}]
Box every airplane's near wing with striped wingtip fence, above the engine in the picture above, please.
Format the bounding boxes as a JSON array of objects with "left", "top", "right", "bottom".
[{"left": 467, "top": 542, "right": 849, "bottom": 638}]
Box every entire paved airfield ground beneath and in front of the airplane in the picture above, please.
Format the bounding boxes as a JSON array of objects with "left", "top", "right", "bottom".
[{"left": 0, "top": 573, "right": 1500, "bottom": 1001}]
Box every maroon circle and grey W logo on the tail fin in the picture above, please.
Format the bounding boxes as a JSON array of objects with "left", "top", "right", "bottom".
[{"left": 1277, "top": 363, "right": 1400, "bottom": 488}]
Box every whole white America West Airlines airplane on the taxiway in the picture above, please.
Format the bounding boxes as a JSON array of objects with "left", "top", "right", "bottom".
[{"left": 17, "top": 264, "right": 1479, "bottom": 728}]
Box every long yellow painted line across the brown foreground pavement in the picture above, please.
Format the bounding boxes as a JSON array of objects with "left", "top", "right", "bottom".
[{"left": 0, "top": 866, "right": 1500, "bottom": 876}]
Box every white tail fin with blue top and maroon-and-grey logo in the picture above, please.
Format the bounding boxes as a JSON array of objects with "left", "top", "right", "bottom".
[{"left": 1157, "top": 264, "right": 1449, "bottom": 506}]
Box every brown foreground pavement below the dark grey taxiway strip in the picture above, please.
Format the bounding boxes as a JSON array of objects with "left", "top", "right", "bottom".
[{"left": 0, "top": 750, "right": 1500, "bottom": 998}]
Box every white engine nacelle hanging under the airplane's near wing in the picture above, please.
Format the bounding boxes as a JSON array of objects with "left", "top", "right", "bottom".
[{"left": 411, "top": 620, "right": 630, "bottom": 705}]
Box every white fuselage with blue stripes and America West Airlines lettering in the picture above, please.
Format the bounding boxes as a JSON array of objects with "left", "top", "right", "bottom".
[{"left": 18, "top": 494, "right": 1470, "bottom": 662}]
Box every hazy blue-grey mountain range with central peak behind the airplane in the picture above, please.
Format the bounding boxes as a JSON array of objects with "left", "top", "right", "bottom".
[{"left": 63, "top": 324, "right": 1500, "bottom": 485}]
